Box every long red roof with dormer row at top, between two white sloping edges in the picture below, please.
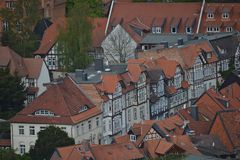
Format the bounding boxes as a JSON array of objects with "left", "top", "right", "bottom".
[{"left": 109, "top": 1, "right": 201, "bottom": 39}]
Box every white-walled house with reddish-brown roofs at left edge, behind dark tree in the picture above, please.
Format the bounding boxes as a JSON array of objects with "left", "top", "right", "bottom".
[{"left": 0, "top": 47, "right": 50, "bottom": 103}]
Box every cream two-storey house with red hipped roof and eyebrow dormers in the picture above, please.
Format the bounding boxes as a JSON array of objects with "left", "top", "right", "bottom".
[{"left": 10, "top": 77, "right": 102, "bottom": 154}]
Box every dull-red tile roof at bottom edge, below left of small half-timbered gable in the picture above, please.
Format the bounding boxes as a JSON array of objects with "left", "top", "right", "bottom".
[{"left": 91, "top": 143, "right": 144, "bottom": 160}]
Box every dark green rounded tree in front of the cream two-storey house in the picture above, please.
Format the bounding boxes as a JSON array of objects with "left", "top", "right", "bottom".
[{"left": 30, "top": 126, "right": 74, "bottom": 160}]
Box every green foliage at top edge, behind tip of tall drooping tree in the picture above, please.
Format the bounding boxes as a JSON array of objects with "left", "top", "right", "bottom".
[{"left": 66, "top": 0, "right": 104, "bottom": 17}]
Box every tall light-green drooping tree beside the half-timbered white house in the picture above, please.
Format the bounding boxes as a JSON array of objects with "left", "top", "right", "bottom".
[{"left": 57, "top": 0, "right": 92, "bottom": 71}]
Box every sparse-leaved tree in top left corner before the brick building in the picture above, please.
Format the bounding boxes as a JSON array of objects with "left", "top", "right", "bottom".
[{"left": 0, "top": 0, "right": 40, "bottom": 57}]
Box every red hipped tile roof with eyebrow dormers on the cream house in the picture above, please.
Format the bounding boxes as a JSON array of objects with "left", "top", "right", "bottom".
[{"left": 11, "top": 77, "right": 101, "bottom": 124}]
